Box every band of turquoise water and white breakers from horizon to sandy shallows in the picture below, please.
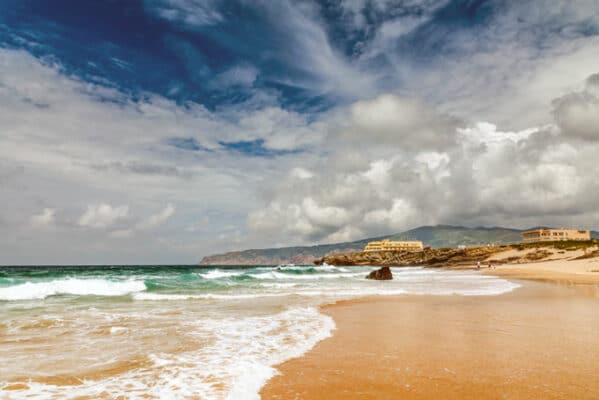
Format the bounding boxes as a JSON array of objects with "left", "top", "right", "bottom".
[{"left": 0, "top": 265, "right": 506, "bottom": 301}]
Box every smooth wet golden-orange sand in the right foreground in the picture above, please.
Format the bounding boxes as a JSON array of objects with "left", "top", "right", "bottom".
[{"left": 261, "top": 281, "right": 599, "bottom": 400}]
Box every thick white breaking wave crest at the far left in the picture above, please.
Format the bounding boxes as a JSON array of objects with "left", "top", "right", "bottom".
[{"left": 0, "top": 278, "right": 146, "bottom": 301}]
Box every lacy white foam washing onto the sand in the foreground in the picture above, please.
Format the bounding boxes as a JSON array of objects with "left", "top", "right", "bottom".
[{"left": 0, "top": 307, "right": 335, "bottom": 400}]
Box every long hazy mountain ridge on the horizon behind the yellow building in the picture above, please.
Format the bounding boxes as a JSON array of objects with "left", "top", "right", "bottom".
[{"left": 200, "top": 225, "right": 528, "bottom": 265}]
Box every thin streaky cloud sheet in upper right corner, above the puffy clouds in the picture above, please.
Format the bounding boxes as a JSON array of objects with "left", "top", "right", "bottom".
[{"left": 360, "top": 0, "right": 599, "bottom": 130}]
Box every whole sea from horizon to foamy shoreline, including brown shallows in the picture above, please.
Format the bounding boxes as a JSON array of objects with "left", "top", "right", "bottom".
[{"left": 0, "top": 265, "right": 518, "bottom": 400}]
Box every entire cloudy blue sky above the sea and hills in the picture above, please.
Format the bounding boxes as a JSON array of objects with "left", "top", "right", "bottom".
[{"left": 0, "top": 0, "right": 599, "bottom": 264}]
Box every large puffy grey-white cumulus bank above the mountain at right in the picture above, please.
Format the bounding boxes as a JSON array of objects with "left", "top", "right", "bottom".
[{"left": 248, "top": 77, "right": 599, "bottom": 243}]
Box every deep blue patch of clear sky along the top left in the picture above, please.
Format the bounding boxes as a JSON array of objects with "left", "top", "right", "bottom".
[{"left": 0, "top": 0, "right": 528, "bottom": 112}]
